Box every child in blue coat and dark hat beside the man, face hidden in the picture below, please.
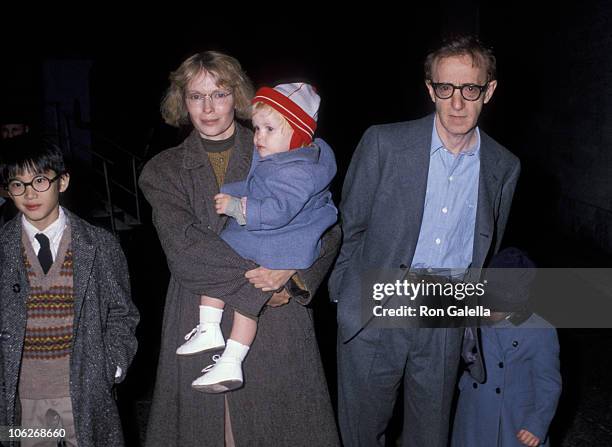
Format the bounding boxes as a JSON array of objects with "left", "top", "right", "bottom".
[{"left": 452, "top": 248, "right": 561, "bottom": 447}]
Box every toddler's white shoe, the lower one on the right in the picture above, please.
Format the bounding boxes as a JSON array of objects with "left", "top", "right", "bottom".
[{"left": 191, "top": 355, "right": 243, "bottom": 393}]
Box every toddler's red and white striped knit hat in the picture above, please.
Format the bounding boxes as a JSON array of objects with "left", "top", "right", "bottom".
[{"left": 251, "top": 82, "right": 321, "bottom": 150}]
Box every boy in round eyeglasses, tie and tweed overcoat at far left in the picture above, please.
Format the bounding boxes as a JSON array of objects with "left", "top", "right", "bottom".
[{"left": 0, "top": 134, "right": 138, "bottom": 447}]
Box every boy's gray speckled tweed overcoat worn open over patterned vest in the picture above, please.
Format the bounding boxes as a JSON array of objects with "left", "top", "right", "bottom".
[{"left": 0, "top": 210, "right": 138, "bottom": 447}]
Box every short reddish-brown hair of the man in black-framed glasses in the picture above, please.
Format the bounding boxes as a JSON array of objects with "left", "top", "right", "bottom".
[{"left": 425, "top": 35, "right": 497, "bottom": 82}]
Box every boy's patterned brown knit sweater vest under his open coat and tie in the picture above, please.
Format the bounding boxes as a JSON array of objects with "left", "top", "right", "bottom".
[{"left": 19, "top": 225, "right": 74, "bottom": 399}]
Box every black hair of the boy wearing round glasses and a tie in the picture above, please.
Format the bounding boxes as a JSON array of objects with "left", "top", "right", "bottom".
[{"left": 0, "top": 133, "right": 66, "bottom": 185}]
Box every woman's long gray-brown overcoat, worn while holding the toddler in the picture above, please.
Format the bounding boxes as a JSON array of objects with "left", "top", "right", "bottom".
[{"left": 140, "top": 125, "right": 340, "bottom": 447}]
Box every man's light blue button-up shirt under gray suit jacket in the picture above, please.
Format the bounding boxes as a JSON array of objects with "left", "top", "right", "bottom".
[{"left": 411, "top": 120, "right": 480, "bottom": 276}]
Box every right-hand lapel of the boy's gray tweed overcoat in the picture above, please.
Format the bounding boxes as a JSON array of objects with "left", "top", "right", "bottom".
[{"left": 65, "top": 210, "right": 96, "bottom": 334}]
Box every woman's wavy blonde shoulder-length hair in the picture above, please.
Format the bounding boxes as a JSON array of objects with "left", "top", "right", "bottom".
[{"left": 161, "top": 51, "right": 254, "bottom": 127}]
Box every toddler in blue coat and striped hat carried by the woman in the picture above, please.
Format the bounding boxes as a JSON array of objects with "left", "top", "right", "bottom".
[{"left": 177, "top": 83, "right": 337, "bottom": 393}]
